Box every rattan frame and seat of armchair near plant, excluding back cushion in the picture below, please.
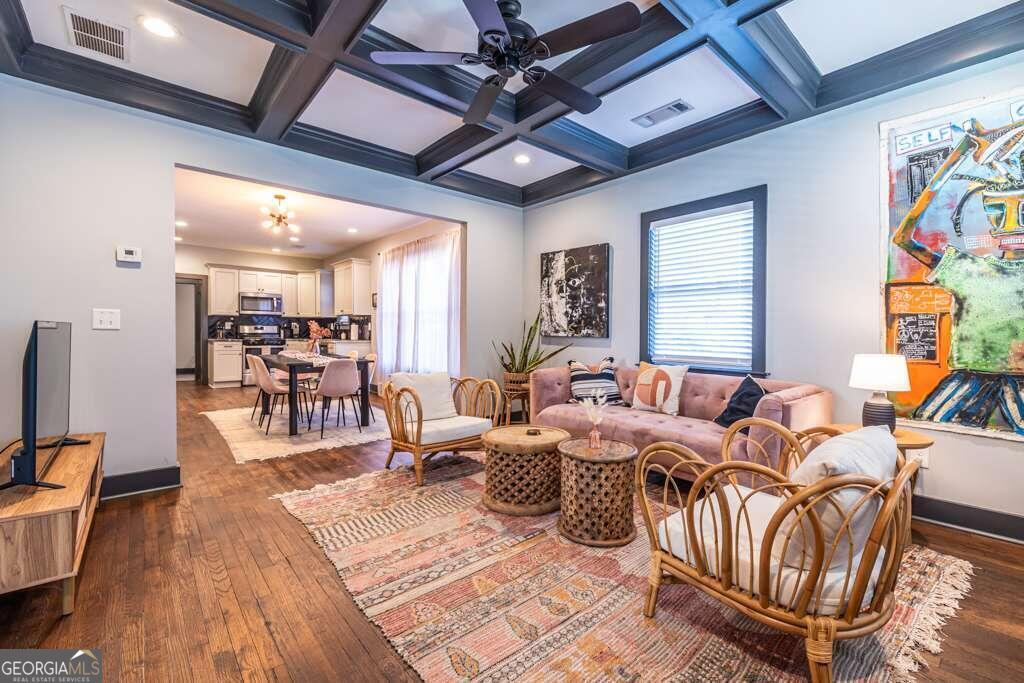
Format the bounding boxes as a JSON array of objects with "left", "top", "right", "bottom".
[{"left": 380, "top": 377, "right": 502, "bottom": 486}]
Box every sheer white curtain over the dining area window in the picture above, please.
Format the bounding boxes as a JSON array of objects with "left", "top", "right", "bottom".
[{"left": 377, "top": 230, "right": 462, "bottom": 377}]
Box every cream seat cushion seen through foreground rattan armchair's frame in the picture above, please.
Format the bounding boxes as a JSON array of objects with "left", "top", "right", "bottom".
[{"left": 657, "top": 485, "right": 885, "bottom": 614}]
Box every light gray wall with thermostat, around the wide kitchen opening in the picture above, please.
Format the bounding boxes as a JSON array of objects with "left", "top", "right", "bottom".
[{"left": 0, "top": 76, "right": 523, "bottom": 474}]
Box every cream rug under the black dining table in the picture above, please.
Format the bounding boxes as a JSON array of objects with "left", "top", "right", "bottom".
[{"left": 200, "top": 405, "right": 391, "bottom": 463}]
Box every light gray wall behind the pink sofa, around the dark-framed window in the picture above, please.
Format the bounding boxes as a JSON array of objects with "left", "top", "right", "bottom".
[{"left": 523, "top": 54, "right": 1024, "bottom": 514}]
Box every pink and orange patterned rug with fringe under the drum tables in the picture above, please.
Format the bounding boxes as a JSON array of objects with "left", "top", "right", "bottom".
[{"left": 275, "top": 450, "right": 971, "bottom": 683}]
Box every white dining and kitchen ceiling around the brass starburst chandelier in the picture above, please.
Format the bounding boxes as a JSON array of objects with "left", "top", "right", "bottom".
[{"left": 174, "top": 168, "right": 436, "bottom": 258}]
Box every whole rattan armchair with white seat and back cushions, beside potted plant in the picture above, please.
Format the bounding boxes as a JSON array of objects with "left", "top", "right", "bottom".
[{"left": 380, "top": 373, "right": 502, "bottom": 486}]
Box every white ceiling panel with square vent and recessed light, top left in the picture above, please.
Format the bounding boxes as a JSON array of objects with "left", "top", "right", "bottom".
[{"left": 22, "top": 0, "right": 273, "bottom": 104}]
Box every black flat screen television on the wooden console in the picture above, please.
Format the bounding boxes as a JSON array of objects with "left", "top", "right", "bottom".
[{"left": 0, "top": 321, "right": 81, "bottom": 488}]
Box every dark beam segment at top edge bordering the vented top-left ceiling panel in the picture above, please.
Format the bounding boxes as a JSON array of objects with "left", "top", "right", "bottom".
[{"left": 165, "top": 0, "right": 313, "bottom": 52}]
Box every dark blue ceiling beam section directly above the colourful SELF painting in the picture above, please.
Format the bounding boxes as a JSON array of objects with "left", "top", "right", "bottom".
[{"left": 817, "top": 2, "right": 1024, "bottom": 112}]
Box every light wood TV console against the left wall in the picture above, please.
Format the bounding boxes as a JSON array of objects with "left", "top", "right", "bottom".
[{"left": 0, "top": 432, "right": 105, "bottom": 614}]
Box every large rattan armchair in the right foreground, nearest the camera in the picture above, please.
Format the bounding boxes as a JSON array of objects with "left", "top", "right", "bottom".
[{"left": 636, "top": 419, "right": 918, "bottom": 683}]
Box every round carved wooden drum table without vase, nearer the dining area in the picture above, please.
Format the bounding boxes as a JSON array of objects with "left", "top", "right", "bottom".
[{"left": 482, "top": 425, "right": 569, "bottom": 516}]
